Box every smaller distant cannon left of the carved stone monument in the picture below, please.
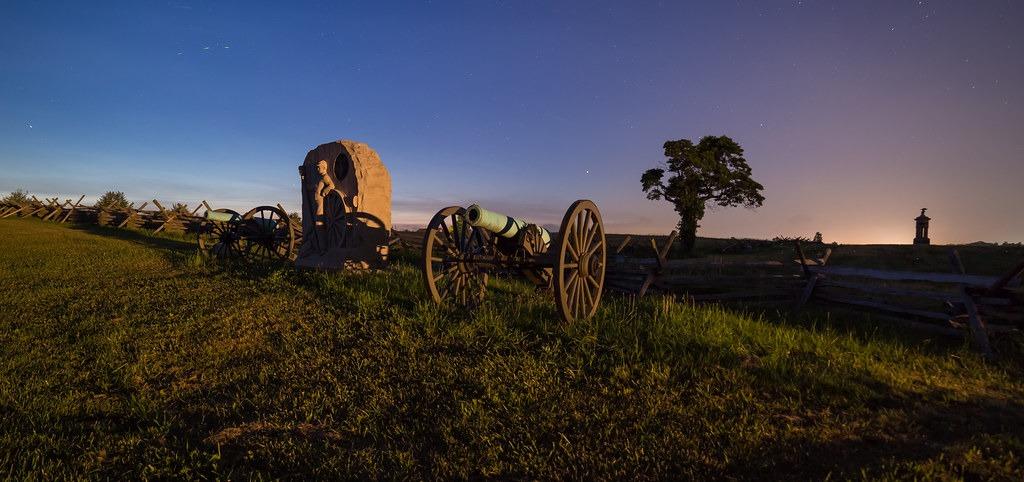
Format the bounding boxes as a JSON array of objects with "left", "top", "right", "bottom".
[{"left": 198, "top": 206, "right": 296, "bottom": 261}]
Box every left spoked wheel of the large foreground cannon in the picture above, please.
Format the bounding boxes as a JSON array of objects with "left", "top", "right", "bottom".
[{"left": 423, "top": 206, "right": 489, "bottom": 306}]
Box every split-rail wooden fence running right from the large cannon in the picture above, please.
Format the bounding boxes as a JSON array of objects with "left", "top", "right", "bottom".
[{"left": 605, "top": 232, "right": 1024, "bottom": 356}]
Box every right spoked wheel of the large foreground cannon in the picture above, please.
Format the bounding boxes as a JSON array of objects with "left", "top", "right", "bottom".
[{"left": 554, "top": 200, "right": 607, "bottom": 322}]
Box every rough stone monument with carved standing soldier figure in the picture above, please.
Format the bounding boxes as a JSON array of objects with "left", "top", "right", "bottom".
[{"left": 295, "top": 140, "right": 391, "bottom": 269}]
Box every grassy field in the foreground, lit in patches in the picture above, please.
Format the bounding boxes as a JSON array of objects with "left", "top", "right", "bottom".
[{"left": 0, "top": 219, "right": 1024, "bottom": 480}]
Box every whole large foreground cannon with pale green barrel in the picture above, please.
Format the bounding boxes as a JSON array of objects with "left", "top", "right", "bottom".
[{"left": 422, "top": 200, "right": 607, "bottom": 322}]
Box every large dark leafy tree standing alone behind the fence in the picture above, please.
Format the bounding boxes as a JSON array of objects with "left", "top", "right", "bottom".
[{"left": 640, "top": 135, "right": 765, "bottom": 253}]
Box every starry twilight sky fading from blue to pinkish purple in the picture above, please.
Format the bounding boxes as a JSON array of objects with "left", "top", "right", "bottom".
[{"left": 0, "top": 0, "right": 1024, "bottom": 243}]
